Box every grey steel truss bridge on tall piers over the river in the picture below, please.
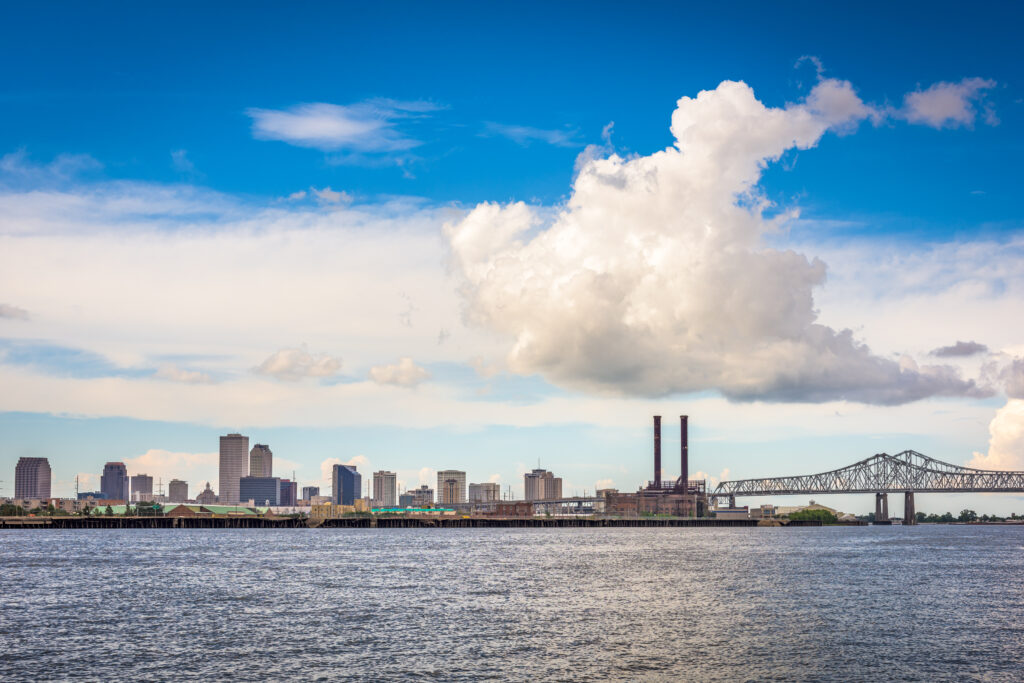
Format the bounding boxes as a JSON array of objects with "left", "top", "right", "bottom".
[{"left": 708, "top": 451, "right": 1024, "bottom": 523}]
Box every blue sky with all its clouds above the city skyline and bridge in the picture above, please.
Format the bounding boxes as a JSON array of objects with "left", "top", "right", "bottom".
[{"left": 0, "top": 2, "right": 1024, "bottom": 514}]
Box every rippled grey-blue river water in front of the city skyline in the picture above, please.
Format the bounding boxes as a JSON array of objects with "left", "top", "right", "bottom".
[{"left": 0, "top": 525, "right": 1024, "bottom": 681}]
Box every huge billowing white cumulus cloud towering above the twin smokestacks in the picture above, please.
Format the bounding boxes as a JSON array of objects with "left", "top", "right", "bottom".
[{"left": 445, "top": 79, "right": 980, "bottom": 403}]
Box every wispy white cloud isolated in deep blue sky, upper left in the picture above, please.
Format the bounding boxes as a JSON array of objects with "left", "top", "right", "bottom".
[{"left": 246, "top": 99, "right": 439, "bottom": 154}]
